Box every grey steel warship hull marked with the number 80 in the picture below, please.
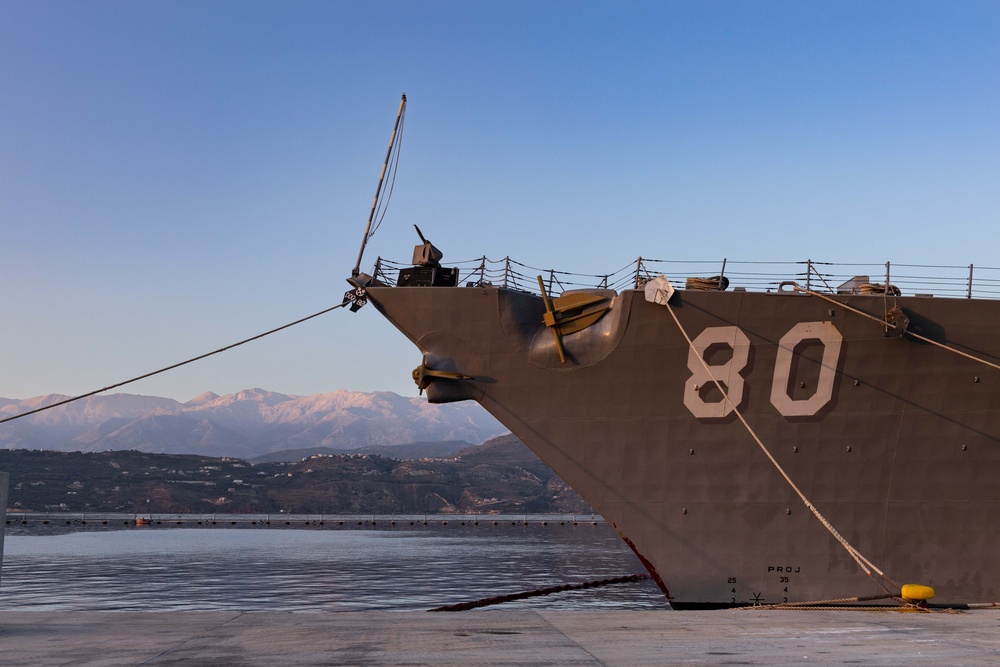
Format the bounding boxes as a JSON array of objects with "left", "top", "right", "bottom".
[{"left": 368, "top": 287, "right": 1000, "bottom": 608}]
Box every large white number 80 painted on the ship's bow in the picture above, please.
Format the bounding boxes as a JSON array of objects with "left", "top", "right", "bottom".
[{"left": 684, "top": 322, "right": 844, "bottom": 419}]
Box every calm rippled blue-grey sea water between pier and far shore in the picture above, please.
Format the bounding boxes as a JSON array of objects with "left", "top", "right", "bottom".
[{"left": 0, "top": 522, "right": 669, "bottom": 612}]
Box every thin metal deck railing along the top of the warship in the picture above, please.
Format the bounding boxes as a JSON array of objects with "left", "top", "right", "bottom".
[{"left": 374, "top": 256, "right": 1000, "bottom": 299}]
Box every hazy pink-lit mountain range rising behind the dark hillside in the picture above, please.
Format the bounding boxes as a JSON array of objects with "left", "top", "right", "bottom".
[{"left": 0, "top": 389, "right": 506, "bottom": 459}]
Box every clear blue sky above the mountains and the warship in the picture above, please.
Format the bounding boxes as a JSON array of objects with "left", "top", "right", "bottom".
[{"left": 0, "top": 0, "right": 1000, "bottom": 400}]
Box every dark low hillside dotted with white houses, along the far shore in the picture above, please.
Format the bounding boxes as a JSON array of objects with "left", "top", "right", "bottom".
[{"left": 0, "top": 436, "right": 591, "bottom": 514}]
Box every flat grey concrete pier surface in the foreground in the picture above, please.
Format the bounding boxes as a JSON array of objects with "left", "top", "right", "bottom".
[{"left": 0, "top": 610, "right": 1000, "bottom": 667}]
